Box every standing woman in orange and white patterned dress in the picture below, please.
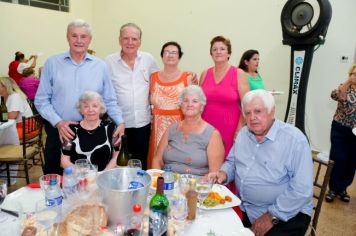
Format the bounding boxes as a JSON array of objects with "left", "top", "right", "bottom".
[{"left": 147, "top": 41, "right": 195, "bottom": 168}]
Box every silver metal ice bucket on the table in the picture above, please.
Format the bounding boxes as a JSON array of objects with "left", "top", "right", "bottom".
[{"left": 96, "top": 167, "right": 151, "bottom": 225}]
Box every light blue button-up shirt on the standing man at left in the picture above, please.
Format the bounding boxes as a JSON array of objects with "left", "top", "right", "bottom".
[{"left": 35, "top": 52, "right": 123, "bottom": 126}]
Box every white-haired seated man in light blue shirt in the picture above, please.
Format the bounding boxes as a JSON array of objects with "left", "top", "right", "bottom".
[{"left": 209, "top": 90, "right": 313, "bottom": 236}]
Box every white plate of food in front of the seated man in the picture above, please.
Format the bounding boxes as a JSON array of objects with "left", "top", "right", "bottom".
[{"left": 198, "top": 184, "right": 241, "bottom": 210}]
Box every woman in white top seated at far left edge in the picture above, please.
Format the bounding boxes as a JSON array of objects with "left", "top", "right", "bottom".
[{"left": 0, "top": 77, "right": 33, "bottom": 140}]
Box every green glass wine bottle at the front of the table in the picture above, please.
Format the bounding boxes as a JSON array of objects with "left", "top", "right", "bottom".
[{"left": 148, "top": 177, "right": 169, "bottom": 236}]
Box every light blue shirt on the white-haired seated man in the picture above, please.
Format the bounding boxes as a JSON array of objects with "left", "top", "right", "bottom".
[{"left": 221, "top": 120, "right": 313, "bottom": 222}]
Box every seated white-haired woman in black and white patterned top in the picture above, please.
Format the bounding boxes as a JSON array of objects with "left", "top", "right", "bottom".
[{"left": 61, "top": 91, "right": 118, "bottom": 171}]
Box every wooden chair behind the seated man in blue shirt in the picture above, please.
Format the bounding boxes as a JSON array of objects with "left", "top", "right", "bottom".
[{"left": 311, "top": 157, "right": 334, "bottom": 236}]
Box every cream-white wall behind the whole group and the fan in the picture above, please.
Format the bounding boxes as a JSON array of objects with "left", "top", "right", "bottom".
[{"left": 0, "top": 0, "right": 356, "bottom": 151}]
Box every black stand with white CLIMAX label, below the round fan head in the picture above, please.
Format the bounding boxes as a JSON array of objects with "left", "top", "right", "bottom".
[{"left": 284, "top": 45, "right": 315, "bottom": 134}]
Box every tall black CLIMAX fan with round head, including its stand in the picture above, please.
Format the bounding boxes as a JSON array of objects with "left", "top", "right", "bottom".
[{"left": 281, "top": 0, "right": 331, "bottom": 133}]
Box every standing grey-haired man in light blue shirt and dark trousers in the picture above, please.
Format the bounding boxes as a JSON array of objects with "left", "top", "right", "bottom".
[{"left": 35, "top": 20, "right": 125, "bottom": 174}]
